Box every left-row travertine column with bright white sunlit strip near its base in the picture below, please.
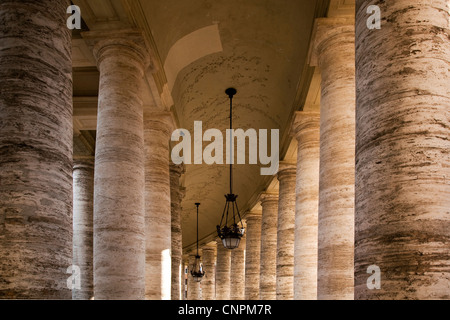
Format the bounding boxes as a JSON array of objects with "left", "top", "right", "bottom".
[{"left": 144, "top": 110, "right": 174, "bottom": 300}]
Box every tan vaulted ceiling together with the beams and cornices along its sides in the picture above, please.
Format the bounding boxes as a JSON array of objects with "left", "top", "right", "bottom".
[{"left": 73, "top": 0, "right": 354, "bottom": 251}]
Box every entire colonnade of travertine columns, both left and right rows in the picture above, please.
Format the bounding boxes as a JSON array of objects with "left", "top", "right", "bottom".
[{"left": 0, "top": 0, "right": 450, "bottom": 300}]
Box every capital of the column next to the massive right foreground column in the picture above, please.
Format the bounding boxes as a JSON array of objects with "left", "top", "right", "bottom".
[{"left": 308, "top": 18, "right": 355, "bottom": 67}]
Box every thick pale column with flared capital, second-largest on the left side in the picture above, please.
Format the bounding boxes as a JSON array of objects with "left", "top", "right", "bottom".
[{"left": 83, "top": 31, "right": 149, "bottom": 300}]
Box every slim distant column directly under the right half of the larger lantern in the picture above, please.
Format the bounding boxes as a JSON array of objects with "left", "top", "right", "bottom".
[{"left": 230, "top": 230, "right": 247, "bottom": 300}]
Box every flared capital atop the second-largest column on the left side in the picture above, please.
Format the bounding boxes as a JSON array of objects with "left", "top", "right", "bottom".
[{"left": 82, "top": 29, "right": 153, "bottom": 72}]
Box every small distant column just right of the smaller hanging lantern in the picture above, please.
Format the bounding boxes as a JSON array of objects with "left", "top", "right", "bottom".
[{"left": 201, "top": 245, "right": 217, "bottom": 300}]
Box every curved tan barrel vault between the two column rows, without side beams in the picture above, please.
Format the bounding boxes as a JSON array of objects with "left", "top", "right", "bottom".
[{"left": 141, "top": 0, "right": 316, "bottom": 246}]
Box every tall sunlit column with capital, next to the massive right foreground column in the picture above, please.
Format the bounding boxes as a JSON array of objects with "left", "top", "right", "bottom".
[{"left": 311, "top": 18, "right": 355, "bottom": 300}]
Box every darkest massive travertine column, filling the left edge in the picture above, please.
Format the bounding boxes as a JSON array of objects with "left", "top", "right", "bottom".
[{"left": 0, "top": 0, "right": 73, "bottom": 299}]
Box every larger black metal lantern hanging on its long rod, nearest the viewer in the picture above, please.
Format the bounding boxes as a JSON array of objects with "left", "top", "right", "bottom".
[{"left": 217, "top": 88, "right": 245, "bottom": 249}]
